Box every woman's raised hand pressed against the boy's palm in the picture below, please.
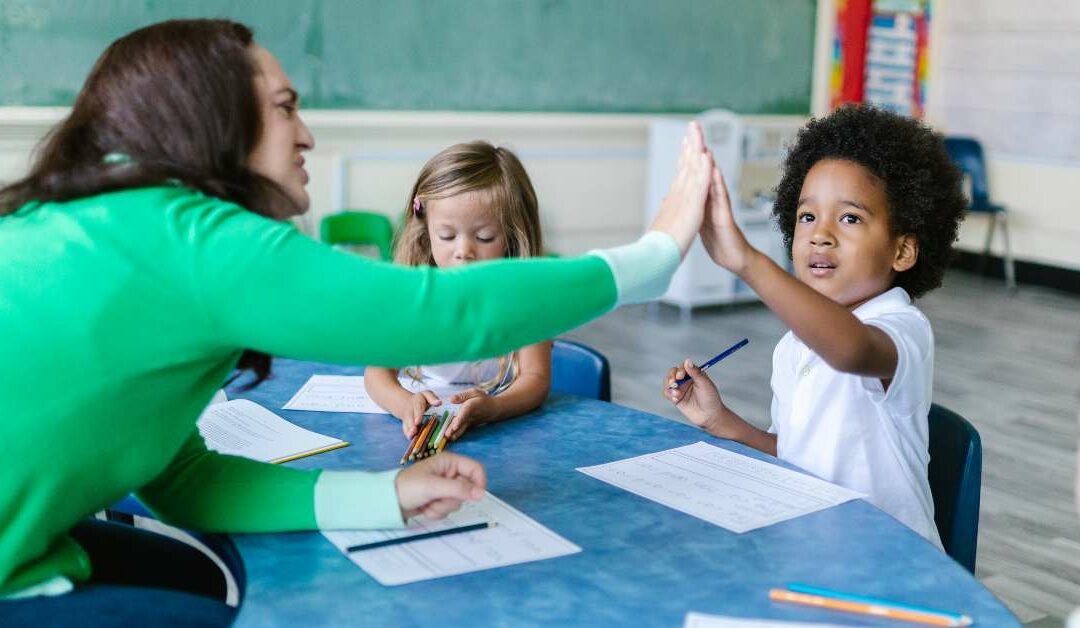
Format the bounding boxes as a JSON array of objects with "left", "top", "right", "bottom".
[{"left": 649, "top": 121, "right": 713, "bottom": 257}]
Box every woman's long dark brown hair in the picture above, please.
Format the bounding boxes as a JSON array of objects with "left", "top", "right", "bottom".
[{"left": 0, "top": 19, "right": 299, "bottom": 386}]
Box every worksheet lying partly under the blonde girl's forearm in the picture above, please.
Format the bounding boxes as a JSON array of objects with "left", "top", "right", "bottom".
[{"left": 282, "top": 375, "right": 471, "bottom": 414}]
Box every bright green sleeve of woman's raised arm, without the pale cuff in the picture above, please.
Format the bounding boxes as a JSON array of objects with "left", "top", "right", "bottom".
[{"left": 178, "top": 194, "right": 622, "bottom": 366}]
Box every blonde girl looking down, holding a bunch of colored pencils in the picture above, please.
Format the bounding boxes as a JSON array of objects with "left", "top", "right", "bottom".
[{"left": 364, "top": 142, "right": 551, "bottom": 439}]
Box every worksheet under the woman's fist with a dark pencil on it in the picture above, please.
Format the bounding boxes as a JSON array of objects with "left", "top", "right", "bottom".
[{"left": 323, "top": 493, "right": 581, "bottom": 586}]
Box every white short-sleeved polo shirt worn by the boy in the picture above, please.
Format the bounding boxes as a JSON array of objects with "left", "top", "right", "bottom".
[{"left": 770, "top": 288, "right": 942, "bottom": 548}]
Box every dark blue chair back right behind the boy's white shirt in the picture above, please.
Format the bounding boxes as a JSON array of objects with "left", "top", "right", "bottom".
[{"left": 929, "top": 403, "right": 983, "bottom": 573}]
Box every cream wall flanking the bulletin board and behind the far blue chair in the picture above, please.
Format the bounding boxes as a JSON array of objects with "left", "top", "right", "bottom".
[{"left": 813, "top": 0, "right": 1080, "bottom": 269}]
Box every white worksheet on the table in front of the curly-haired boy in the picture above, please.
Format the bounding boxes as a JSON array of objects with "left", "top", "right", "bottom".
[{"left": 578, "top": 442, "right": 864, "bottom": 533}]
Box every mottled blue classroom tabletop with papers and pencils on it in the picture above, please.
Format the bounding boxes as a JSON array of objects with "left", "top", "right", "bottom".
[{"left": 228, "top": 360, "right": 1020, "bottom": 627}]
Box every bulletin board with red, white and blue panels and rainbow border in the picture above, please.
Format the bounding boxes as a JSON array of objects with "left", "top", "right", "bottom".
[{"left": 829, "top": 0, "right": 930, "bottom": 118}]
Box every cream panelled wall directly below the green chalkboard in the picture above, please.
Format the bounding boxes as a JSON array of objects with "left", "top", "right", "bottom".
[{"left": 0, "top": 107, "right": 801, "bottom": 254}]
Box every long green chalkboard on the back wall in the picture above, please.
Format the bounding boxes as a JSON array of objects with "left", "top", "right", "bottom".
[{"left": 0, "top": 0, "right": 815, "bottom": 113}]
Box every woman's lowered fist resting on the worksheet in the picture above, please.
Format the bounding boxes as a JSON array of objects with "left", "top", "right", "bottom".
[{"left": 394, "top": 452, "right": 487, "bottom": 519}]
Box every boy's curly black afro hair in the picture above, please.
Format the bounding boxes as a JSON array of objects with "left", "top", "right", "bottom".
[{"left": 772, "top": 105, "right": 968, "bottom": 298}]
